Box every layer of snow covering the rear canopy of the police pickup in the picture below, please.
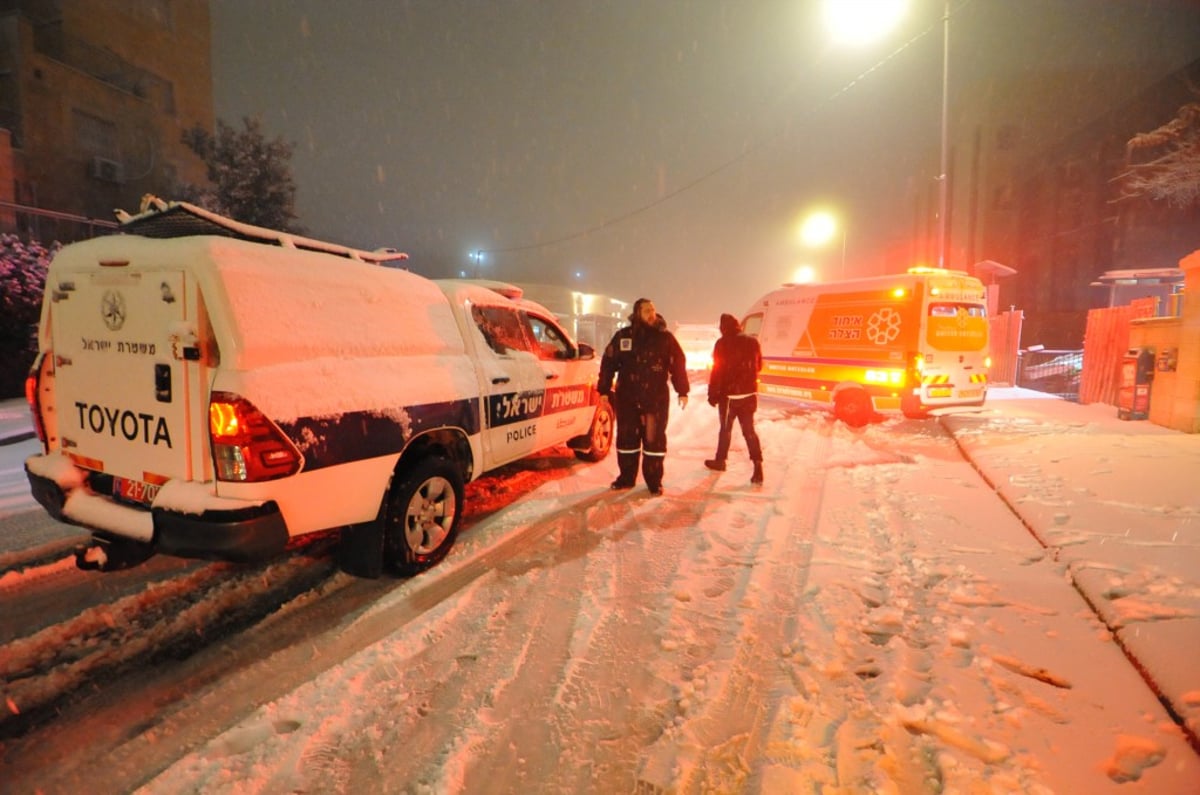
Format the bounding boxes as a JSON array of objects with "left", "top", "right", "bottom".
[{"left": 50, "top": 210, "right": 463, "bottom": 371}]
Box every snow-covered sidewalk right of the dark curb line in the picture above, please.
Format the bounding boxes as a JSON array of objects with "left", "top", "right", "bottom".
[{"left": 941, "top": 389, "right": 1200, "bottom": 754}]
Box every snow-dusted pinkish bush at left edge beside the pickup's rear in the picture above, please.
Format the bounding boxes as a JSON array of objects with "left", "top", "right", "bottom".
[{"left": 0, "top": 234, "right": 61, "bottom": 398}]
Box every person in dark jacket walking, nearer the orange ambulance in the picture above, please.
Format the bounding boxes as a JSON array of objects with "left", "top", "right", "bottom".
[{"left": 704, "top": 315, "right": 762, "bottom": 483}]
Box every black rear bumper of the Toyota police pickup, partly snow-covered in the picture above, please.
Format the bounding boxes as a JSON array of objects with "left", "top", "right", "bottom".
[{"left": 25, "top": 464, "right": 289, "bottom": 563}]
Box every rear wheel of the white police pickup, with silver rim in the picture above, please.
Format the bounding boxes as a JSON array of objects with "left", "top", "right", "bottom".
[{"left": 383, "top": 456, "right": 463, "bottom": 576}]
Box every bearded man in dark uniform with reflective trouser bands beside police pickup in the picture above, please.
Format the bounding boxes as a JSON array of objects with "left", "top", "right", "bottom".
[{"left": 596, "top": 298, "right": 689, "bottom": 495}]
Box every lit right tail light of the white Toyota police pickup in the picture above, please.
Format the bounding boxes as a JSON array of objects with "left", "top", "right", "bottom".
[{"left": 209, "top": 391, "right": 304, "bottom": 483}]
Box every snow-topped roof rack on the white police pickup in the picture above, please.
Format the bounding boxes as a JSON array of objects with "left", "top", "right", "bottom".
[{"left": 116, "top": 195, "right": 408, "bottom": 264}]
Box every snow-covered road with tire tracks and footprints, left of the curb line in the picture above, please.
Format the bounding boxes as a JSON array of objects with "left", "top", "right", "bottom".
[{"left": 0, "top": 401, "right": 1200, "bottom": 793}]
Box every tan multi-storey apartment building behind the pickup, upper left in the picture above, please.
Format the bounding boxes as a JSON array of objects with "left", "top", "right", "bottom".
[{"left": 0, "top": 0, "right": 215, "bottom": 243}]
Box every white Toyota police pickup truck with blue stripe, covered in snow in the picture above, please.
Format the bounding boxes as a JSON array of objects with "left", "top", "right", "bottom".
[{"left": 25, "top": 199, "right": 612, "bottom": 576}]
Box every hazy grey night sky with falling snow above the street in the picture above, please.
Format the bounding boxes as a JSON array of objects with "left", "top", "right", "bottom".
[{"left": 212, "top": 0, "right": 1200, "bottom": 323}]
